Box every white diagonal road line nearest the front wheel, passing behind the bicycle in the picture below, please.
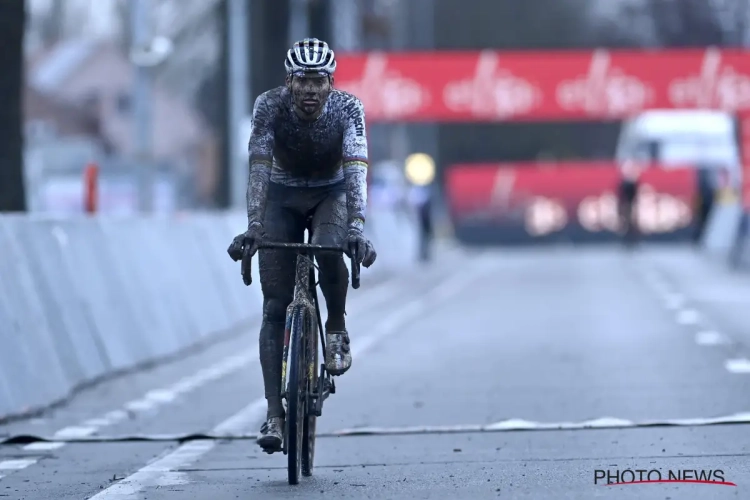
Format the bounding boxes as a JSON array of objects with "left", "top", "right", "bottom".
[{"left": 89, "top": 256, "right": 496, "bottom": 500}]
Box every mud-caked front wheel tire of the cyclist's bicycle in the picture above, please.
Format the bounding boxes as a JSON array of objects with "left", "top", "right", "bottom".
[{"left": 286, "top": 307, "right": 307, "bottom": 484}]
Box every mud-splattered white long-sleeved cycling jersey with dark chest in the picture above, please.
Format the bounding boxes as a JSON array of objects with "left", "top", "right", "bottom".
[{"left": 247, "top": 86, "right": 368, "bottom": 231}]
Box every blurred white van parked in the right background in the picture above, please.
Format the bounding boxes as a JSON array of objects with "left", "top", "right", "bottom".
[{"left": 615, "top": 110, "right": 742, "bottom": 190}]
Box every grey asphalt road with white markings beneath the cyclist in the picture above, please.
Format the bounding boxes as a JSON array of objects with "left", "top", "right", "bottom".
[{"left": 0, "top": 247, "right": 750, "bottom": 500}]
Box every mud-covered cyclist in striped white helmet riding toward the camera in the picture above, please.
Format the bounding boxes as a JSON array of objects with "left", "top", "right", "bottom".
[{"left": 223, "top": 38, "right": 377, "bottom": 453}]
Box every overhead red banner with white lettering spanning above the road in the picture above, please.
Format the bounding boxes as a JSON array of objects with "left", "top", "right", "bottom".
[{"left": 335, "top": 48, "right": 750, "bottom": 122}]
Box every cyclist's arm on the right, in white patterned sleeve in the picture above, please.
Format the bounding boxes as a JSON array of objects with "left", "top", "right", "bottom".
[{"left": 343, "top": 96, "right": 369, "bottom": 231}]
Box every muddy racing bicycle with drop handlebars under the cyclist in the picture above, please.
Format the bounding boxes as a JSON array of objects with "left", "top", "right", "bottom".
[{"left": 242, "top": 218, "right": 360, "bottom": 485}]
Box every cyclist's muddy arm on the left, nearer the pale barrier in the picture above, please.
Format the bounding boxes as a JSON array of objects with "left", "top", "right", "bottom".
[{"left": 247, "top": 94, "right": 274, "bottom": 228}]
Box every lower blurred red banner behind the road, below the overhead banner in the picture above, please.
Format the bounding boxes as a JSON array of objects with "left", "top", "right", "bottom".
[{"left": 446, "top": 162, "right": 696, "bottom": 237}]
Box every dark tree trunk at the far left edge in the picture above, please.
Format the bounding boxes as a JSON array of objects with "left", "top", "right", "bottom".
[{"left": 0, "top": 0, "right": 26, "bottom": 212}]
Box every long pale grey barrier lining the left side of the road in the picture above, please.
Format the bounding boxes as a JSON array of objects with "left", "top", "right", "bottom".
[{"left": 0, "top": 208, "right": 414, "bottom": 421}]
